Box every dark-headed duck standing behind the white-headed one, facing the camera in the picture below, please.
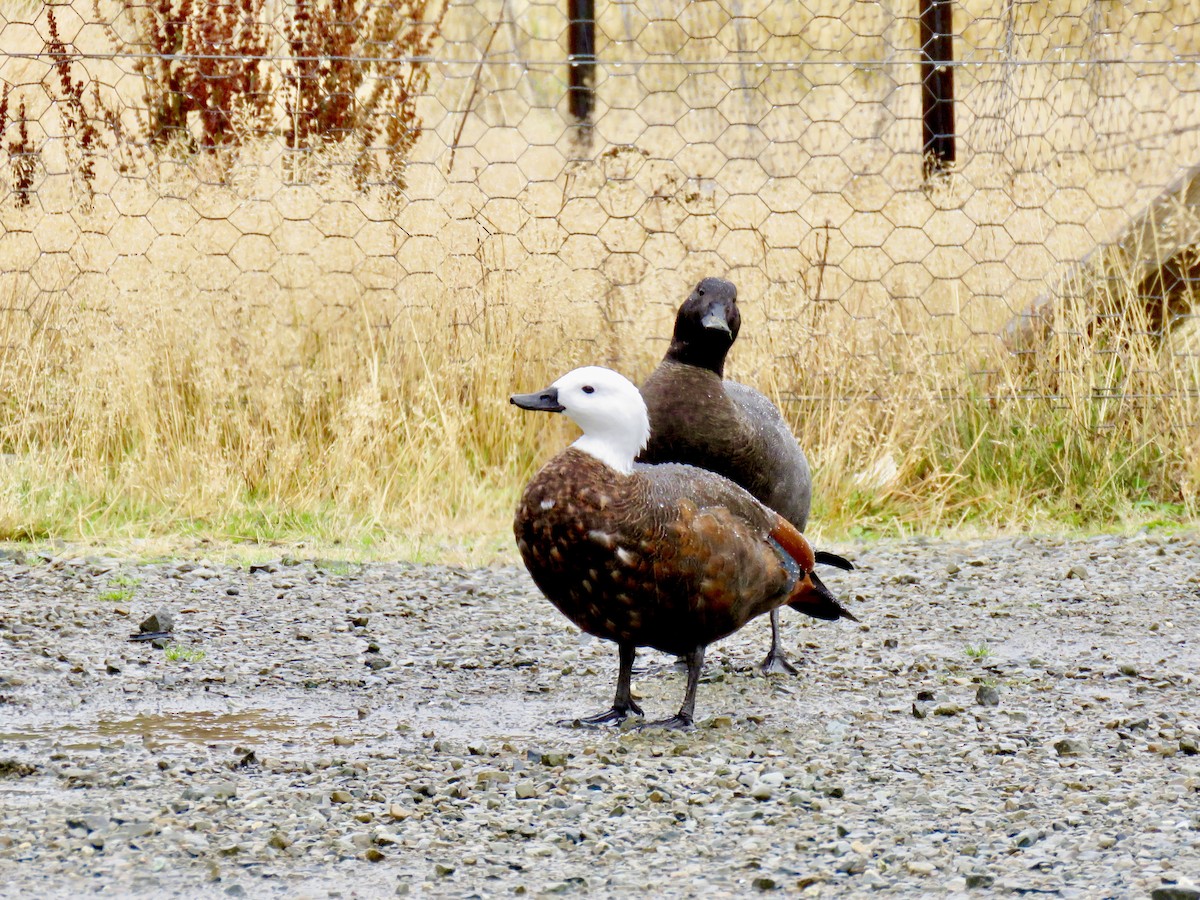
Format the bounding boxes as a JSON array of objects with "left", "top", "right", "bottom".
[{"left": 637, "top": 278, "right": 853, "bottom": 674}]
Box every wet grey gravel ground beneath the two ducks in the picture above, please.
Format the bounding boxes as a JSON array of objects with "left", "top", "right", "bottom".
[{"left": 0, "top": 534, "right": 1200, "bottom": 900}]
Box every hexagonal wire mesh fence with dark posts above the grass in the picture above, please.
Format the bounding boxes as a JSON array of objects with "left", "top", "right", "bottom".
[{"left": 0, "top": 0, "right": 1200, "bottom": 415}]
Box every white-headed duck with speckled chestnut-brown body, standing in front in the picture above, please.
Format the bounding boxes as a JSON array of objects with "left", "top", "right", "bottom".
[{"left": 511, "top": 366, "right": 857, "bottom": 727}]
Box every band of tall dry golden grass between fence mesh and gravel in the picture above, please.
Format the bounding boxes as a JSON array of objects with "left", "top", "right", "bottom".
[{"left": 0, "top": 250, "right": 1200, "bottom": 559}]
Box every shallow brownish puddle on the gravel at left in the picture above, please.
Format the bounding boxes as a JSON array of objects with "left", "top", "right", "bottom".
[{"left": 0, "top": 709, "right": 332, "bottom": 750}]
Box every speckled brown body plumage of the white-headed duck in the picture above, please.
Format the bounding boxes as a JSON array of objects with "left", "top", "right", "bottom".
[{"left": 515, "top": 449, "right": 812, "bottom": 655}]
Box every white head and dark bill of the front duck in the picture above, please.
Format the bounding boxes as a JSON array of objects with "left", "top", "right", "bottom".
[{"left": 509, "top": 366, "right": 650, "bottom": 475}]
